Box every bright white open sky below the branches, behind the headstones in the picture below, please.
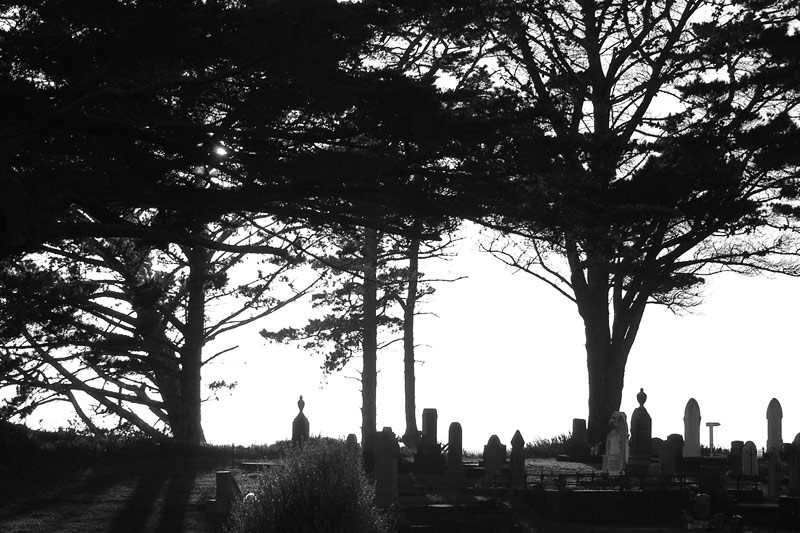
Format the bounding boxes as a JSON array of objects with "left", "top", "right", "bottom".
[{"left": 203, "top": 222, "right": 800, "bottom": 451}]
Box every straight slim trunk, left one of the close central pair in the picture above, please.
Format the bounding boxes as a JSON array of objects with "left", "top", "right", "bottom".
[{"left": 361, "top": 228, "right": 378, "bottom": 445}]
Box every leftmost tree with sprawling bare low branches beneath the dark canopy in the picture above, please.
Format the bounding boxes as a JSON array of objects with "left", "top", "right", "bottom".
[{"left": 0, "top": 211, "right": 318, "bottom": 443}]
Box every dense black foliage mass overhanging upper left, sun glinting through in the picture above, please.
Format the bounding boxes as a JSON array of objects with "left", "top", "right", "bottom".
[{"left": 0, "top": 0, "right": 488, "bottom": 255}]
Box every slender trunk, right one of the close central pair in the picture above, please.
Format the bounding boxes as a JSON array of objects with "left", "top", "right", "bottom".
[{"left": 403, "top": 239, "right": 420, "bottom": 448}]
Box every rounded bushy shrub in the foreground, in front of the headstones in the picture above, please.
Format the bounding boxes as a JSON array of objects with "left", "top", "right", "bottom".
[{"left": 228, "top": 440, "right": 390, "bottom": 533}]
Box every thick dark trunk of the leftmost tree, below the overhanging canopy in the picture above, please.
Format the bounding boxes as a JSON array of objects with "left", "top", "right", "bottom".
[{"left": 178, "top": 247, "right": 209, "bottom": 444}]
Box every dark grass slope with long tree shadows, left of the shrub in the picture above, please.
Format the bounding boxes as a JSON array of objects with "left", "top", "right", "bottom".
[{"left": 0, "top": 425, "right": 287, "bottom": 533}]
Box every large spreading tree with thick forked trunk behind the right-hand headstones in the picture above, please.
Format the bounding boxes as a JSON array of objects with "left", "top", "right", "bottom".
[{"left": 412, "top": 0, "right": 800, "bottom": 442}]
